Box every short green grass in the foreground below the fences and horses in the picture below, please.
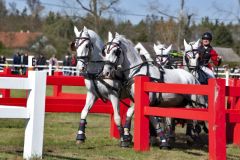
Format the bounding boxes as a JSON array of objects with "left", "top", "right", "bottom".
[{"left": 0, "top": 113, "right": 240, "bottom": 160}]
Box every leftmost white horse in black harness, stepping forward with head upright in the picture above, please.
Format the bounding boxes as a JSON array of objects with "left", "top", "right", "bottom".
[{"left": 71, "top": 27, "right": 126, "bottom": 143}]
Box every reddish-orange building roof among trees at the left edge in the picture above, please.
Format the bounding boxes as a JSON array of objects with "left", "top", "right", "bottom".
[{"left": 0, "top": 31, "right": 42, "bottom": 48}]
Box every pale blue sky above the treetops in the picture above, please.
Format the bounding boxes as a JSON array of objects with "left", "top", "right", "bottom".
[{"left": 5, "top": 0, "right": 240, "bottom": 24}]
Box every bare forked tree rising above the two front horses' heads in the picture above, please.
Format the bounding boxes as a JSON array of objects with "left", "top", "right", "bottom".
[{"left": 76, "top": 0, "right": 119, "bottom": 33}]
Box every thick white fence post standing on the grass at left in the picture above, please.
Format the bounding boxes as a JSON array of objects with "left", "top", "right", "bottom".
[{"left": 23, "top": 71, "right": 46, "bottom": 159}]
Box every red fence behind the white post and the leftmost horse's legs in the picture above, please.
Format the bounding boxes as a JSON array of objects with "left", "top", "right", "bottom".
[{"left": 0, "top": 68, "right": 130, "bottom": 138}]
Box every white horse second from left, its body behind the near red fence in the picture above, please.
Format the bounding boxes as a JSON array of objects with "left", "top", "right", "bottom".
[{"left": 103, "top": 33, "right": 204, "bottom": 149}]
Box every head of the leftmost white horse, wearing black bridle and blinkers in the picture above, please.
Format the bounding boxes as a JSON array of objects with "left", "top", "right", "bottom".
[{"left": 71, "top": 26, "right": 93, "bottom": 72}]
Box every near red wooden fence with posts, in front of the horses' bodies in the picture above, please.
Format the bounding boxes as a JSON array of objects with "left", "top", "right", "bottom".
[{"left": 134, "top": 76, "right": 240, "bottom": 160}]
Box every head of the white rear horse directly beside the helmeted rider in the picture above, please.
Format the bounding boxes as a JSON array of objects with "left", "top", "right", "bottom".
[{"left": 184, "top": 39, "right": 200, "bottom": 69}]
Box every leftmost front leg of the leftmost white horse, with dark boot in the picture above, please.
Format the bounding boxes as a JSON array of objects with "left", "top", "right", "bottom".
[{"left": 76, "top": 92, "right": 97, "bottom": 144}]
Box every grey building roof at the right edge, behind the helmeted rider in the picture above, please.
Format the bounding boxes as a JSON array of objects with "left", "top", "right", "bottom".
[{"left": 213, "top": 47, "right": 240, "bottom": 62}]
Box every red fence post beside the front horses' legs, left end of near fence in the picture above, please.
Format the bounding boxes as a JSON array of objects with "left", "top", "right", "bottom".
[{"left": 134, "top": 76, "right": 149, "bottom": 151}]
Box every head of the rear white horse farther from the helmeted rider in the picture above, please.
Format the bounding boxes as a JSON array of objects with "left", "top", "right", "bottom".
[{"left": 153, "top": 42, "right": 172, "bottom": 66}]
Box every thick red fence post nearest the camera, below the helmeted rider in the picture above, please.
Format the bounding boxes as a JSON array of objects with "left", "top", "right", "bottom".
[{"left": 208, "top": 79, "right": 226, "bottom": 160}]
